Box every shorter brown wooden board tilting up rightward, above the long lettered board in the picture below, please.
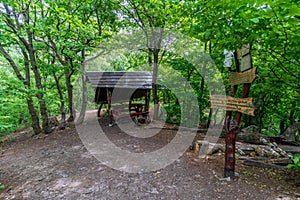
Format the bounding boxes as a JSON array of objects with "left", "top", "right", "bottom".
[{"left": 228, "top": 67, "right": 257, "bottom": 85}]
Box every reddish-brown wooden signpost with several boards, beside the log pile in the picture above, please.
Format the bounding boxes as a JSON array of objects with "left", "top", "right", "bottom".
[{"left": 216, "top": 45, "right": 257, "bottom": 178}]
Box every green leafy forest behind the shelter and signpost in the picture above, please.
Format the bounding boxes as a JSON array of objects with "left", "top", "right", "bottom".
[{"left": 0, "top": 0, "right": 300, "bottom": 141}]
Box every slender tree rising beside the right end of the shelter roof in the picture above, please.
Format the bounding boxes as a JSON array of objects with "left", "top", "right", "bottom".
[{"left": 115, "top": 0, "right": 186, "bottom": 119}]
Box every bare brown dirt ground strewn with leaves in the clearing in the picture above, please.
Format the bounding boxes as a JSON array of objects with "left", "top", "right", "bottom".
[{"left": 0, "top": 111, "right": 300, "bottom": 199}]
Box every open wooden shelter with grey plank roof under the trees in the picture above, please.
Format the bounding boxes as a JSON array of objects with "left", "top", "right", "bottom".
[{"left": 86, "top": 71, "right": 152, "bottom": 124}]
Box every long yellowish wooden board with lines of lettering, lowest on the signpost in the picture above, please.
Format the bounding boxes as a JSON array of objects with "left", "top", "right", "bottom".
[{"left": 210, "top": 95, "right": 255, "bottom": 116}]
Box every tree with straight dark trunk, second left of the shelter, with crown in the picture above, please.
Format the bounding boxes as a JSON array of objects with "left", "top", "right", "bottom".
[{"left": 37, "top": 0, "right": 116, "bottom": 121}]
